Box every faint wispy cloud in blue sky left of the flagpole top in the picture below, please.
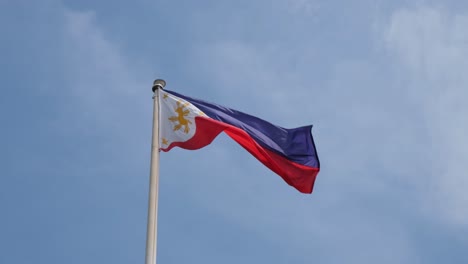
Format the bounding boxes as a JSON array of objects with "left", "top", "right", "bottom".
[{"left": 62, "top": 9, "right": 151, "bottom": 123}]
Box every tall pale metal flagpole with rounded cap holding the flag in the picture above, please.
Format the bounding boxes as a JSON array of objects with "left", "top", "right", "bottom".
[{"left": 145, "top": 79, "right": 166, "bottom": 264}]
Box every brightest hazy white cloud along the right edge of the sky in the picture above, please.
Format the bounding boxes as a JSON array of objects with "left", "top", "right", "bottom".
[{"left": 385, "top": 8, "right": 468, "bottom": 227}]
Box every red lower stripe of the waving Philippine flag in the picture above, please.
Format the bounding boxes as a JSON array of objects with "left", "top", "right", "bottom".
[{"left": 161, "top": 117, "right": 319, "bottom": 193}]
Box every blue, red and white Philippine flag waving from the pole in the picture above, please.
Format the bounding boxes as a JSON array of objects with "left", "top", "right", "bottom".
[{"left": 157, "top": 89, "right": 320, "bottom": 193}]
